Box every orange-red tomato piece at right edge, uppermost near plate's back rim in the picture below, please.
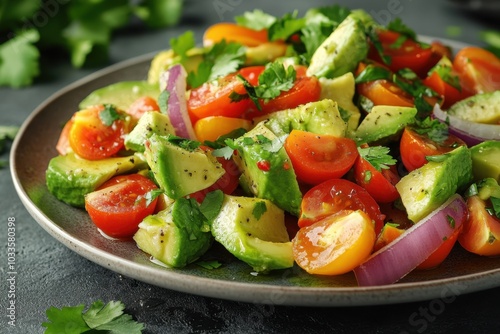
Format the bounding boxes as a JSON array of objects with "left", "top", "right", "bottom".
[{"left": 453, "top": 46, "right": 500, "bottom": 94}]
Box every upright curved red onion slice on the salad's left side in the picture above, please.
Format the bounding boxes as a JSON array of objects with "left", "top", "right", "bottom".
[{"left": 160, "top": 64, "right": 196, "bottom": 140}]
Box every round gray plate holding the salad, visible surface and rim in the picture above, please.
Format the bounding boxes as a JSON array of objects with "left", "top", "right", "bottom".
[{"left": 10, "top": 38, "right": 500, "bottom": 306}]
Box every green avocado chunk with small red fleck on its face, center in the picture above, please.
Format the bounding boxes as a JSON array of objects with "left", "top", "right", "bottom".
[{"left": 233, "top": 122, "right": 302, "bottom": 215}]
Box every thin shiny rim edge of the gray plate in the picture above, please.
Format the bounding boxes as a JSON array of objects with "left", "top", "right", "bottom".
[{"left": 10, "top": 35, "right": 500, "bottom": 307}]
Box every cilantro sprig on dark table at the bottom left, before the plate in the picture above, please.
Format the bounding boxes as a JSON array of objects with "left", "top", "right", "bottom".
[{"left": 42, "top": 300, "right": 144, "bottom": 334}]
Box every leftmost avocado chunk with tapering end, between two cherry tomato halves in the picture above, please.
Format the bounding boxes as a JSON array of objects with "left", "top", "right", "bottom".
[{"left": 45, "top": 153, "right": 148, "bottom": 207}]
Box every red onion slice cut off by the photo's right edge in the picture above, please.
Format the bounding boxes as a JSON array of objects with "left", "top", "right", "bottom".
[{"left": 432, "top": 104, "right": 500, "bottom": 147}]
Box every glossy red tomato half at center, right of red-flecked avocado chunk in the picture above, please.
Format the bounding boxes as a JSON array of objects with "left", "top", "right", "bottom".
[{"left": 284, "top": 130, "right": 359, "bottom": 185}]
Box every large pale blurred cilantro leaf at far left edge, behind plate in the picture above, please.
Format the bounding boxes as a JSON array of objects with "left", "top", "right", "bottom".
[{"left": 0, "top": 30, "right": 40, "bottom": 88}]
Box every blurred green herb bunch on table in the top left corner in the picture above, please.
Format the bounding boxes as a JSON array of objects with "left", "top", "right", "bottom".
[{"left": 0, "top": 0, "right": 183, "bottom": 88}]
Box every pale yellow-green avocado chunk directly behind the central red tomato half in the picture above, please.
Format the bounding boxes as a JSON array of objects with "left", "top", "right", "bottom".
[{"left": 265, "top": 99, "right": 347, "bottom": 137}]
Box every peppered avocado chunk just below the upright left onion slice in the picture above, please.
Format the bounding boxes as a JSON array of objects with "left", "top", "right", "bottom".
[{"left": 144, "top": 133, "right": 225, "bottom": 200}]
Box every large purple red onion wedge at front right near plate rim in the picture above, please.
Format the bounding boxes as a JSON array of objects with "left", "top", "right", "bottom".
[{"left": 354, "top": 194, "right": 467, "bottom": 286}]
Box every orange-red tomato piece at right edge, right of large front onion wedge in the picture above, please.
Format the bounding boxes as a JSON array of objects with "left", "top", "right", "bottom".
[{"left": 458, "top": 195, "right": 500, "bottom": 256}]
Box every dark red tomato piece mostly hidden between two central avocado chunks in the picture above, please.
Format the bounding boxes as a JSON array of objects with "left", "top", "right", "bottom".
[{"left": 189, "top": 146, "right": 241, "bottom": 203}]
